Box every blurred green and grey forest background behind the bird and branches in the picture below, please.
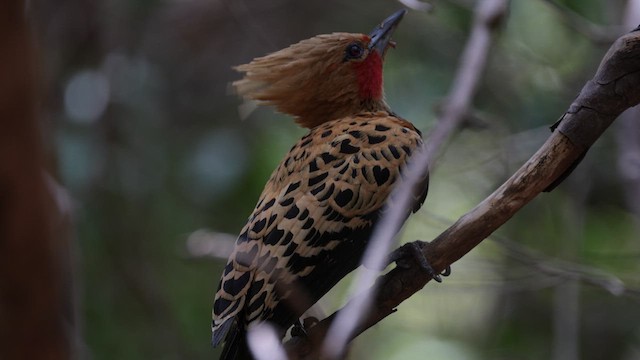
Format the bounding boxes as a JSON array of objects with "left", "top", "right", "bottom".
[{"left": 22, "top": 0, "right": 640, "bottom": 360}]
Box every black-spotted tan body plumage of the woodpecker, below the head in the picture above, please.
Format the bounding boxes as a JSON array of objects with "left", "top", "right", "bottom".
[{"left": 213, "top": 111, "right": 427, "bottom": 356}]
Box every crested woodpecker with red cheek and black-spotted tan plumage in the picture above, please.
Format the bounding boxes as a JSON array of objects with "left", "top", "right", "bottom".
[{"left": 212, "top": 10, "right": 428, "bottom": 359}]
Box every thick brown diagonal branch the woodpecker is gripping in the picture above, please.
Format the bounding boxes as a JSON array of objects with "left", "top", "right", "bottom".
[{"left": 286, "top": 23, "right": 640, "bottom": 360}]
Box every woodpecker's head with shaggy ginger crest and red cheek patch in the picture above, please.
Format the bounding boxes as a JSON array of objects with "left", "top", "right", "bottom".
[{"left": 233, "top": 10, "right": 406, "bottom": 128}]
